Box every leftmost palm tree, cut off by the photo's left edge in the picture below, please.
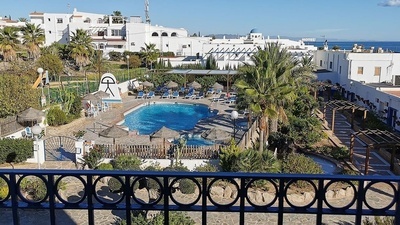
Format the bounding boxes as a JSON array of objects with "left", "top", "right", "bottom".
[{"left": 0, "top": 27, "right": 20, "bottom": 61}]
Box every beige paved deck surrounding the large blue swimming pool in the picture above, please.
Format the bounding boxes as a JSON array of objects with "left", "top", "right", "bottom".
[{"left": 46, "top": 95, "right": 246, "bottom": 145}]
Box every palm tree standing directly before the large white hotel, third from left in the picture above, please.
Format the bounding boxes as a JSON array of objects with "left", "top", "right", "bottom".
[{"left": 69, "top": 29, "right": 94, "bottom": 70}]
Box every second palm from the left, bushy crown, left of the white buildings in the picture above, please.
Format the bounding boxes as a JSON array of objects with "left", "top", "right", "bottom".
[{"left": 21, "top": 23, "right": 45, "bottom": 60}]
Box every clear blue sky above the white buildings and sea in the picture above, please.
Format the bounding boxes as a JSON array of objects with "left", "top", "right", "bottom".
[{"left": 0, "top": 0, "right": 400, "bottom": 41}]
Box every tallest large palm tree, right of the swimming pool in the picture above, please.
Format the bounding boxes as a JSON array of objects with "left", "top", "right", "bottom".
[{"left": 235, "top": 43, "right": 297, "bottom": 152}]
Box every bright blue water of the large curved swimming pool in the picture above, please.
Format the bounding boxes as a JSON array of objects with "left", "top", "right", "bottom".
[{"left": 124, "top": 103, "right": 216, "bottom": 135}]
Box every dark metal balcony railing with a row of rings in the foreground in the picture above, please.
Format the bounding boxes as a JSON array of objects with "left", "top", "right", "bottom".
[{"left": 0, "top": 169, "right": 400, "bottom": 225}]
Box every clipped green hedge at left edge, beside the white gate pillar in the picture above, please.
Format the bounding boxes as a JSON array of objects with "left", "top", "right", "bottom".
[{"left": 0, "top": 138, "right": 33, "bottom": 163}]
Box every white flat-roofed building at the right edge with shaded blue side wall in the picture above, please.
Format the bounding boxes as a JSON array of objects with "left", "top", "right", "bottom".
[{"left": 314, "top": 45, "right": 400, "bottom": 130}]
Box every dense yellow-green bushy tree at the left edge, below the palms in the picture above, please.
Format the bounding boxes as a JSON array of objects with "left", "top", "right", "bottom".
[{"left": 0, "top": 74, "right": 40, "bottom": 118}]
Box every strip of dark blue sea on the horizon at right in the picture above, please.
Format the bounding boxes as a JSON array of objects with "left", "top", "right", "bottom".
[{"left": 305, "top": 40, "right": 400, "bottom": 53}]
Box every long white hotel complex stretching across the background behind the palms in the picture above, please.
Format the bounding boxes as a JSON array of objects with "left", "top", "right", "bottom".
[{"left": 29, "top": 9, "right": 316, "bottom": 69}]
